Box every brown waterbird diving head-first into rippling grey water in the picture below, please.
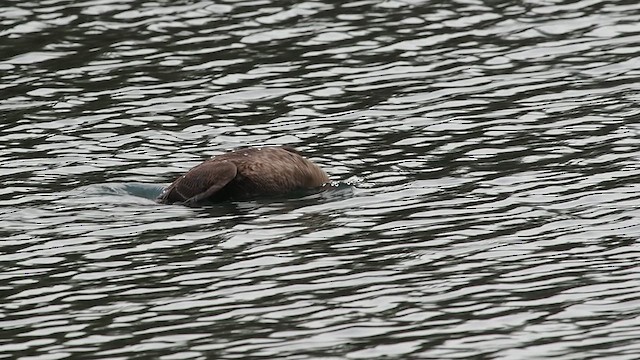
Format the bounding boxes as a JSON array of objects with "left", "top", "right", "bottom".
[{"left": 157, "top": 147, "right": 329, "bottom": 205}]
